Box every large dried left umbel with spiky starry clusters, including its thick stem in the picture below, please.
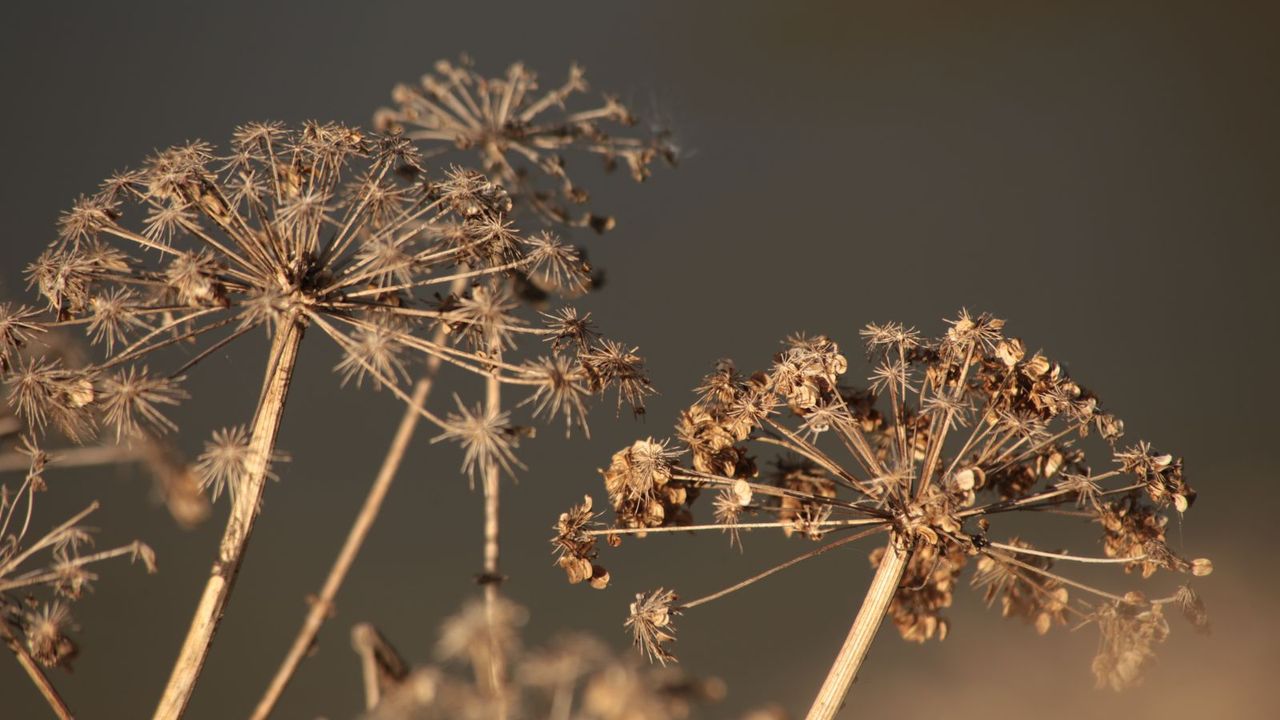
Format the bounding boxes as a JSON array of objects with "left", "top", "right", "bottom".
[{"left": 0, "top": 123, "right": 648, "bottom": 717}]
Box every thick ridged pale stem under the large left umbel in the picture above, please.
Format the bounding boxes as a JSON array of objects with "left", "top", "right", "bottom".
[{"left": 154, "top": 315, "right": 303, "bottom": 720}]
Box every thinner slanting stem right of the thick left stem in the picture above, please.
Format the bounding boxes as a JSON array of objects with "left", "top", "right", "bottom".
[{"left": 251, "top": 315, "right": 455, "bottom": 720}]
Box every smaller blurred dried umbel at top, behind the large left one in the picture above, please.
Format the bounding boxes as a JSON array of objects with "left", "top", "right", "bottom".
[{"left": 374, "top": 59, "right": 677, "bottom": 232}]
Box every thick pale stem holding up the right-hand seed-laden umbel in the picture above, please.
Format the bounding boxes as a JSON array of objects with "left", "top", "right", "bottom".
[{"left": 808, "top": 539, "right": 910, "bottom": 720}]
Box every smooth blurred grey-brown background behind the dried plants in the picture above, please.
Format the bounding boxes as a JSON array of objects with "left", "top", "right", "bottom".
[{"left": 0, "top": 0, "right": 1280, "bottom": 720}]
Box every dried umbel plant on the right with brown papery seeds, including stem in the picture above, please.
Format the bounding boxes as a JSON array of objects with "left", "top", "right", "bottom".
[{"left": 553, "top": 311, "right": 1212, "bottom": 717}]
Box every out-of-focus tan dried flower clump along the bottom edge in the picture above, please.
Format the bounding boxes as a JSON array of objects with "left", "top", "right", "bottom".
[{"left": 352, "top": 600, "right": 783, "bottom": 720}]
